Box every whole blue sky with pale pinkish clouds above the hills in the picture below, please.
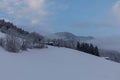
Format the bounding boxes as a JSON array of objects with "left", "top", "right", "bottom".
[{"left": 0, "top": 0, "right": 120, "bottom": 36}]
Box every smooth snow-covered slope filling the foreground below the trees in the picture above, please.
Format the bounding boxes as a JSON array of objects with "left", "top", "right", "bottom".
[{"left": 0, "top": 47, "right": 120, "bottom": 80}]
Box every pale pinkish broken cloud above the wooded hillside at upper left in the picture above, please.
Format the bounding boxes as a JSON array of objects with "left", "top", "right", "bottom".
[{"left": 0, "top": 0, "right": 50, "bottom": 25}]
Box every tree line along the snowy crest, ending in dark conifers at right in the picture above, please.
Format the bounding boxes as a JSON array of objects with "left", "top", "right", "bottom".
[{"left": 47, "top": 39, "right": 100, "bottom": 56}]
